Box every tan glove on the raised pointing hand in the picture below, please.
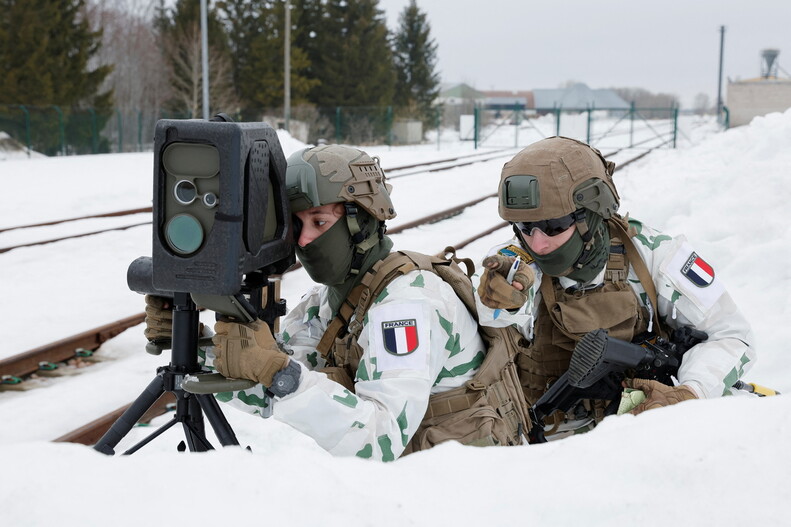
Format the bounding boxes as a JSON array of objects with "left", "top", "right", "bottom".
[{"left": 478, "top": 254, "right": 536, "bottom": 309}]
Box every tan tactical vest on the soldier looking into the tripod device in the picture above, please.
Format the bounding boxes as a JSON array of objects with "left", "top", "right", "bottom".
[{"left": 317, "top": 247, "right": 530, "bottom": 455}]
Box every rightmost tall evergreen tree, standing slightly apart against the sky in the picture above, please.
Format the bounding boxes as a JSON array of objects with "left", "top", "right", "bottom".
[{"left": 393, "top": 0, "right": 439, "bottom": 121}]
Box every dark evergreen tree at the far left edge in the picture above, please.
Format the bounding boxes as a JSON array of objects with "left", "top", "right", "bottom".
[{"left": 0, "top": 0, "right": 112, "bottom": 154}]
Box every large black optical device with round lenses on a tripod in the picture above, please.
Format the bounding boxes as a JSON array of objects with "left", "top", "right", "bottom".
[{"left": 94, "top": 114, "right": 295, "bottom": 454}]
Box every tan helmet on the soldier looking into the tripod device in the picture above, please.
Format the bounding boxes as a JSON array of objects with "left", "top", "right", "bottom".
[{"left": 286, "top": 145, "right": 396, "bottom": 221}]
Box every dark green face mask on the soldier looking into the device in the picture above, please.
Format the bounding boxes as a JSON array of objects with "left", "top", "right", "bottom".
[{"left": 296, "top": 217, "right": 354, "bottom": 285}]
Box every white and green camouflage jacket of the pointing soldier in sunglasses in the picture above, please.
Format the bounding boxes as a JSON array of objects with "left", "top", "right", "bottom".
[{"left": 473, "top": 219, "right": 755, "bottom": 398}]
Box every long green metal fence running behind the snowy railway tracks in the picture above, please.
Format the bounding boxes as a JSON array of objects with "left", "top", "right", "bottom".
[{"left": 0, "top": 105, "right": 678, "bottom": 155}]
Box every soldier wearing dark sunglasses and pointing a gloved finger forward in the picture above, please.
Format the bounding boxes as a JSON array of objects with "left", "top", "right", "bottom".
[{"left": 477, "top": 137, "right": 755, "bottom": 436}]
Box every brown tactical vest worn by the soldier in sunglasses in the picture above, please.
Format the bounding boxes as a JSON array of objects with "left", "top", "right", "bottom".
[{"left": 517, "top": 218, "right": 664, "bottom": 425}]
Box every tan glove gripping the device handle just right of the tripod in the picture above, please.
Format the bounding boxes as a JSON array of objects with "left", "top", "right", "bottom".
[{"left": 212, "top": 321, "right": 288, "bottom": 387}]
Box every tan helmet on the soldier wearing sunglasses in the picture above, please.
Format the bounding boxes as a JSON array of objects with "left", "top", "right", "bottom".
[{"left": 498, "top": 137, "right": 620, "bottom": 222}]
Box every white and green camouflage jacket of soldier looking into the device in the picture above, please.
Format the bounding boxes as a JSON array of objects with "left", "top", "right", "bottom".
[{"left": 205, "top": 271, "right": 486, "bottom": 461}]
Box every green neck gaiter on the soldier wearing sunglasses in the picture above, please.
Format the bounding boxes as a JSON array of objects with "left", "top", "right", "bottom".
[{"left": 522, "top": 214, "right": 610, "bottom": 282}]
